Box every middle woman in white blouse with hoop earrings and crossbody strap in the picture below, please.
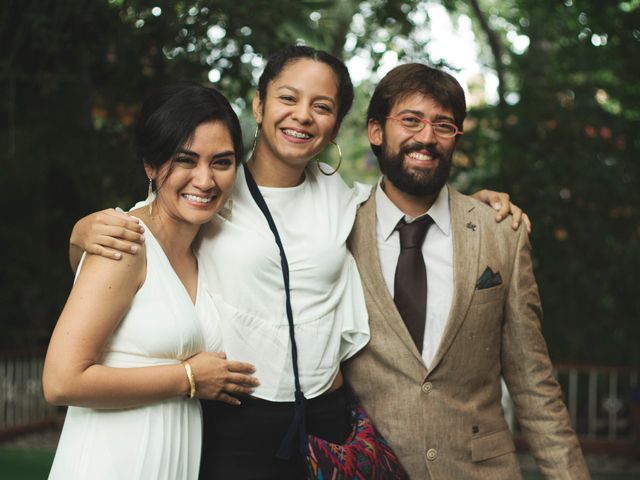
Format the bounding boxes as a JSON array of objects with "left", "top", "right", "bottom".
[{"left": 71, "top": 46, "right": 524, "bottom": 479}]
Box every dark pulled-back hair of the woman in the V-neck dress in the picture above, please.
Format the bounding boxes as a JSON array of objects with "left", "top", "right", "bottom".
[{"left": 134, "top": 81, "right": 243, "bottom": 172}]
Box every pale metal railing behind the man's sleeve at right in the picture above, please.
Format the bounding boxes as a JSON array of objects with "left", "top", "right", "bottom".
[{"left": 503, "top": 364, "right": 640, "bottom": 453}]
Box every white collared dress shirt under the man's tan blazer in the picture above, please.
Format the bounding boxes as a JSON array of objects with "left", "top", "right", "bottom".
[{"left": 375, "top": 177, "right": 453, "bottom": 368}]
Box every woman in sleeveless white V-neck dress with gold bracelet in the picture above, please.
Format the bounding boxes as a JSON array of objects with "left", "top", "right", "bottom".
[{"left": 43, "top": 83, "right": 258, "bottom": 480}]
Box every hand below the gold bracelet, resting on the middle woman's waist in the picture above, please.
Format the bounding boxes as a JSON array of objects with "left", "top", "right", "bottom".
[{"left": 188, "top": 352, "right": 260, "bottom": 405}]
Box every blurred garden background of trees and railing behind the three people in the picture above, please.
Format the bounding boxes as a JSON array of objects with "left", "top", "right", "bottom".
[{"left": 0, "top": 0, "right": 640, "bottom": 478}]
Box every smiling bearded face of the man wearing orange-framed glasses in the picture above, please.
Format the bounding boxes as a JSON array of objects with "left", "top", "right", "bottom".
[{"left": 368, "top": 93, "right": 457, "bottom": 197}]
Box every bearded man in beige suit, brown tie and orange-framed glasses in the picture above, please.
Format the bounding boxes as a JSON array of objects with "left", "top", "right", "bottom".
[{"left": 345, "top": 64, "right": 589, "bottom": 480}]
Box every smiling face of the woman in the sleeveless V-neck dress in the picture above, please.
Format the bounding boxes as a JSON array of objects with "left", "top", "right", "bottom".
[{"left": 145, "top": 121, "right": 236, "bottom": 225}]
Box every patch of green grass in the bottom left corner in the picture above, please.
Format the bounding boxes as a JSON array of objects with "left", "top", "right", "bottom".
[{"left": 0, "top": 448, "right": 54, "bottom": 480}]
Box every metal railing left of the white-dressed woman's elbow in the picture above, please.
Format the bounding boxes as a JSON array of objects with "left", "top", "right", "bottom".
[{"left": 0, "top": 351, "right": 58, "bottom": 439}]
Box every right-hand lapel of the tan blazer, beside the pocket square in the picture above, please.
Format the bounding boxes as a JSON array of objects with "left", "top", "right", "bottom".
[{"left": 429, "top": 187, "right": 480, "bottom": 371}]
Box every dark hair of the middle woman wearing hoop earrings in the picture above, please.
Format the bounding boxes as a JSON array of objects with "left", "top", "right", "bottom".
[{"left": 258, "top": 45, "right": 353, "bottom": 131}]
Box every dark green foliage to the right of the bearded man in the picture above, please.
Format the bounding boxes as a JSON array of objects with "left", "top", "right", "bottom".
[{"left": 456, "top": 0, "right": 640, "bottom": 364}]
